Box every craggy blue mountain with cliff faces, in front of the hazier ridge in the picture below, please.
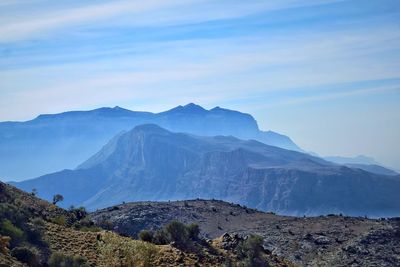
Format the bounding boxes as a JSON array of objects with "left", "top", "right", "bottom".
[{"left": 15, "top": 124, "right": 400, "bottom": 216}]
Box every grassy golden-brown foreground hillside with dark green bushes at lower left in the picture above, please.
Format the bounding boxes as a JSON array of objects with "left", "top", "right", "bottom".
[{"left": 0, "top": 182, "right": 293, "bottom": 267}]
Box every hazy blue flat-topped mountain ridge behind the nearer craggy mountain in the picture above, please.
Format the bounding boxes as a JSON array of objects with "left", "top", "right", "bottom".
[{"left": 0, "top": 103, "right": 300, "bottom": 180}]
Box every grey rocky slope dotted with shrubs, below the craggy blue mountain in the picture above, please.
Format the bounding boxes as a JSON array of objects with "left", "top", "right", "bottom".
[{"left": 90, "top": 200, "right": 400, "bottom": 266}]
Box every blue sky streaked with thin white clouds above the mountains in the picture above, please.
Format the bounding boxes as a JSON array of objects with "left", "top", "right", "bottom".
[{"left": 0, "top": 0, "right": 400, "bottom": 170}]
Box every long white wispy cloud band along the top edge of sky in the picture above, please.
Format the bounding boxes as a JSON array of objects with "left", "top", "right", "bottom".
[{"left": 0, "top": 0, "right": 344, "bottom": 43}]
